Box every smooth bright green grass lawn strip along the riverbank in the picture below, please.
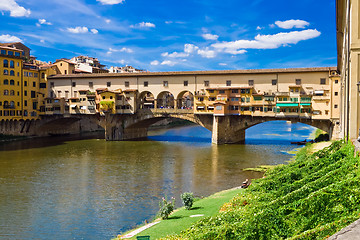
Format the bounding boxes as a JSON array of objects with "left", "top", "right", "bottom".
[{"left": 115, "top": 189, "right": 242, "bottom": 239}]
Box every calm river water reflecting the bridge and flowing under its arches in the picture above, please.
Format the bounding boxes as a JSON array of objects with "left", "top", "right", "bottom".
[{"left": 0, "top": 121, "right": 314, "bottom": 239}]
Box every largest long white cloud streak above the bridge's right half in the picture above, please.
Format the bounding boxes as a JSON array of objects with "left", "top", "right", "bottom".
[{"left": 211, "top": 29, "right": 321, "bottom": 54}]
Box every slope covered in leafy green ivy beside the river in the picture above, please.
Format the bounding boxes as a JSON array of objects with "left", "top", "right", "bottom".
[{"left": 167, "top": 141, "right": 360, "bottom": 240}]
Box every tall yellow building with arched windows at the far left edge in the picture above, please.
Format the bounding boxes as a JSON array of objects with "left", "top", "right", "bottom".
[{"left": 0, "top": 46, "right": 23, "bottom": 120}]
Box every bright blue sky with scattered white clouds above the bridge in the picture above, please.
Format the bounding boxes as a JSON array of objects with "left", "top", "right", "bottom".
[{"left": 0, "top": 0, "right": 336, "bottom": 71}]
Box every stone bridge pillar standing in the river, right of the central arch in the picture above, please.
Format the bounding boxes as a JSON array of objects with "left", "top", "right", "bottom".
[{"left": 211, "top": 116, "right": 245, "bottom": 144}]
